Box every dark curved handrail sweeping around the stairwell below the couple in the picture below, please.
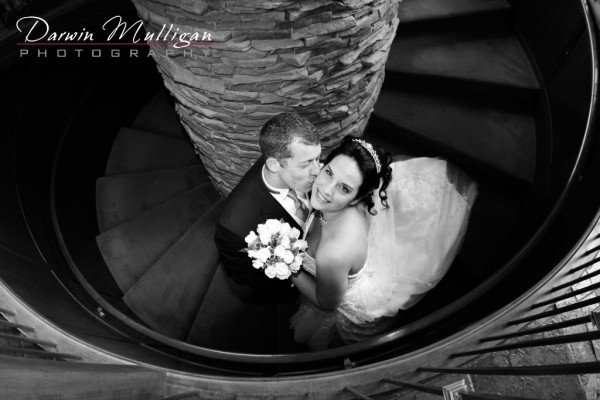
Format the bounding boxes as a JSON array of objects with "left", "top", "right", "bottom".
[{"left": 50, "top": 0, "right": 598, "bottom": 364}]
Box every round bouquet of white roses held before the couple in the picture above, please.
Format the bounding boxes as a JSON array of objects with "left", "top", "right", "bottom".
[{"left": 245, "top": 219, "right": 307, "bottom": 280}]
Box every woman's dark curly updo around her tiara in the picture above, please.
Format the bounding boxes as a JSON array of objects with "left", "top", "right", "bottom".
[{"left": 325, "top": 136, "right": 392, "bottom": 215}]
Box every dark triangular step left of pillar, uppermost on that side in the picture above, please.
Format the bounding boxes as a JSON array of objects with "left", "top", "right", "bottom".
[{"left": 131, "top": 88, "right": 186, "bottom": 138}]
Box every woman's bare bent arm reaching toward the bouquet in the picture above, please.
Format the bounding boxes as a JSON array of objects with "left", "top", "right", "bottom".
[{"left": 292, "top": 246, "right": 352, "bottom": 311}]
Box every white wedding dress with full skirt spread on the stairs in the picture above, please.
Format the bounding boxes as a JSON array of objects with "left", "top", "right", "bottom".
[{"left": 290, "top": 158, "right": 477, "bottom": 350}]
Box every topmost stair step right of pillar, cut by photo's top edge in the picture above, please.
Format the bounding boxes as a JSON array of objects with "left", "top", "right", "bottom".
[{"left": 398, "top": 0, "right": 510, "bottom": 24}]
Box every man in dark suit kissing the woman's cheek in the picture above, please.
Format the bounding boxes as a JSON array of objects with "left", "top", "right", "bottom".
[{"left": 215, "top": 113, "right": 321, "bottom": 303}]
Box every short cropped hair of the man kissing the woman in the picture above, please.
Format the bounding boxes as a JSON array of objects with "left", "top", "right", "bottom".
[{"left": 258, "top": 113, "right": 321, "bottom": 160}]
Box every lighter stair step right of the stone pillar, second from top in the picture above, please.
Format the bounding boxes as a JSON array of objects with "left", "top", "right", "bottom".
[{"left": 386, "top": 24, "right": 539, "bottom": 90}]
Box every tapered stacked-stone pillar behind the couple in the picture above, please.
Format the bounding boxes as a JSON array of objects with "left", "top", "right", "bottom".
[{"left": 133, "top": 0, "right": 398, "bottom": 194}]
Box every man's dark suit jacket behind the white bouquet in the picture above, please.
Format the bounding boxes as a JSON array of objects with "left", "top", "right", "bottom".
[{"left": 215, "top": 157, "right": 302, "bottom": 302}]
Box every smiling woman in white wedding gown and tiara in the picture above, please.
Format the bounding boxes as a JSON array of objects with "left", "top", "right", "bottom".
[{"left": 290, "top": 137, "right": 477, "bottom": 350}]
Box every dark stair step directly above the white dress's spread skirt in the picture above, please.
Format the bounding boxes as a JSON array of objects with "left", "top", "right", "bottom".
[{"left": 372, "top": 90, "right": 536, "bottom": 183}]
